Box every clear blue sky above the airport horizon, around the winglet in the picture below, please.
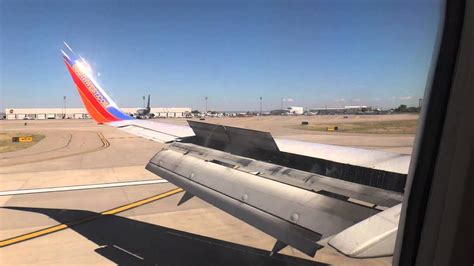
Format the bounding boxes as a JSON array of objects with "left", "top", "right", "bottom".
[{"left": 0, "top": 0, "right": 440, "bottom": 110}]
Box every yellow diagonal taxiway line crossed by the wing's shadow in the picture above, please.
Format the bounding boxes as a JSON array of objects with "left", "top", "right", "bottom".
[{"left": 0, "top": 188, "right": 183, "bottom": 248}]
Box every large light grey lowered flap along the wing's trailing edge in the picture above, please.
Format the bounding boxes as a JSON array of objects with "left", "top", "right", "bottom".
[{"left": 147, "top": 146, "right": 379, "bottom": 256}]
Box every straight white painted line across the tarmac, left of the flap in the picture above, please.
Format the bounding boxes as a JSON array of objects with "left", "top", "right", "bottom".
[{"left": 0, "top": 179, "right": 168, "bottom": 197}]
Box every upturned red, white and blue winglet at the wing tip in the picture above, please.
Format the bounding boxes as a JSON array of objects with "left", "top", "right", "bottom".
[{"left": 61, "top": 43, "right": 133, "bottom": 124}]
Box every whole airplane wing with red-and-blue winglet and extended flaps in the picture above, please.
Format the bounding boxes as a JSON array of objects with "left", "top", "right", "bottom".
[{"left": 62, "top": 45, "right": 410, "bottom": 257}]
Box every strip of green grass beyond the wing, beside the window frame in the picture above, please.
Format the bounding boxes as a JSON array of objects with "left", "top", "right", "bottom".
[{"left": 296, "top": 120, "right": 418, "bottom": 134}]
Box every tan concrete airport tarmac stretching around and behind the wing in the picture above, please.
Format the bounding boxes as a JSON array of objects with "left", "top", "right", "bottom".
[{"left": 0, "top": 117, "right": 414, "bottom": 265}]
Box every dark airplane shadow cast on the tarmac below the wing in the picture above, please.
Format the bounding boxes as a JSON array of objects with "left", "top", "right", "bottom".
[{"left": 3, "top": 207, "right": 326, "bottom": 265}]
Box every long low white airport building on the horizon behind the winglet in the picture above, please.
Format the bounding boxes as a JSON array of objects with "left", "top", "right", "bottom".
[{"left": 5, "top": 107, "right": 191, "bottom": 120}]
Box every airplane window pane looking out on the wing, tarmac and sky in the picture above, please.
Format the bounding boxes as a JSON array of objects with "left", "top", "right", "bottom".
[{"left": 0, "top": 0, "right": 444, "bottom": 265}]
